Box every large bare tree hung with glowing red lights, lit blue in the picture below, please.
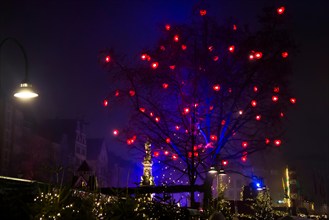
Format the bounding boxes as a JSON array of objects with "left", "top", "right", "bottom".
[{"left": 100, "top": 3, "right": 296, "bottom": 206}]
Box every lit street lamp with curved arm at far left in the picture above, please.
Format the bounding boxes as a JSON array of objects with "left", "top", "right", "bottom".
[{"left": 0, "top": 37, "right": 39, "bottom": 99}]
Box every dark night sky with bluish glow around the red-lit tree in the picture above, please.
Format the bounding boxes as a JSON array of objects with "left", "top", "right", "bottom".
[{"left": 0, "top": 0, "right": 329, "bottom": 199}]
